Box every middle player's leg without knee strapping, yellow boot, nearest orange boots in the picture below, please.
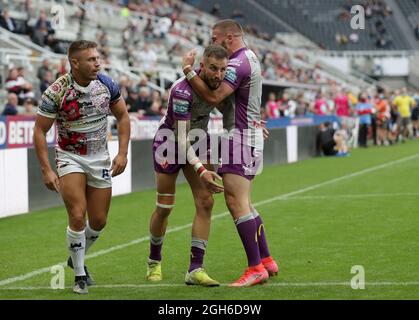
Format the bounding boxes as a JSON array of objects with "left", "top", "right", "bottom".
[{"left": 183, "top": 165, "right": 220, "bottom": 287}]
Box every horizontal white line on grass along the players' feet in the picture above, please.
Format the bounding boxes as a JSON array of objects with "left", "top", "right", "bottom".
[{"left": 0, "top": 281, "right": 419, "bottom": 291}]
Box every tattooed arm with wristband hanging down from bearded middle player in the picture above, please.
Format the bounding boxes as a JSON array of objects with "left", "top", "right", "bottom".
[{"left": 175, "top": 120, "right": 224, "bottom": 193}]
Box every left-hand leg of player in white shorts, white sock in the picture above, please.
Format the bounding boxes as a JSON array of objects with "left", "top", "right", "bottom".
[{"left": 60, "top": 173, "right": 88, "bottom": 294}]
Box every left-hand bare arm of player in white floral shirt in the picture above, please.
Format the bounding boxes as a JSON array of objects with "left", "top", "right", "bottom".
[{"left": 33, "top": 114, "right": 60, "bottom": 192}]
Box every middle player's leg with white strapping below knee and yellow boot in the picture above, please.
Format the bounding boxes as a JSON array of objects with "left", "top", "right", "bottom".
[{"left": 146, "top": 172, "right": 178, "bottom": 281}]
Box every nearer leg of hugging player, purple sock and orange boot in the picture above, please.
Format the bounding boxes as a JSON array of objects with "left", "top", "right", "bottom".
[{"left": 223, "top": 173, "right": 269, "bottom": 287}]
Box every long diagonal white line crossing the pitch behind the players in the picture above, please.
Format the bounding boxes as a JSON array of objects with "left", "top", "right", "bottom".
[{"left": 0, "top": 154, "right": 419, "bottom": 286}]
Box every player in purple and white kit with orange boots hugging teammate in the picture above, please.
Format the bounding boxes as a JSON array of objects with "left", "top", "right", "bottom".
[{"left": 182, "top": 20, "right": 278, "bottom": 287}]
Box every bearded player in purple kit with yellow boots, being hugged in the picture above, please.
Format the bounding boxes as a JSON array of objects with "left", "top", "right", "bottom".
[{"left": 146, "top": 45, "right": 228, "bottom": 286}]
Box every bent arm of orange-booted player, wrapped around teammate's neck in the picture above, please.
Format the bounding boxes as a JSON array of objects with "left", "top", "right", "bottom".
[{"left": 182, "top": 49, "right": 234, "bottom": 105}]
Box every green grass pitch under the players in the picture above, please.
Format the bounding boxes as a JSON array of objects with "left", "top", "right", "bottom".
[{"left": 0, "top": 141, "right": 419, "bottom": 300}]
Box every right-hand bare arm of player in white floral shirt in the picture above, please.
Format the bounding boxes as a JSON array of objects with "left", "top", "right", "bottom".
[{"left": 111, "top": 97, "right": 131, "bottom": 177}]
